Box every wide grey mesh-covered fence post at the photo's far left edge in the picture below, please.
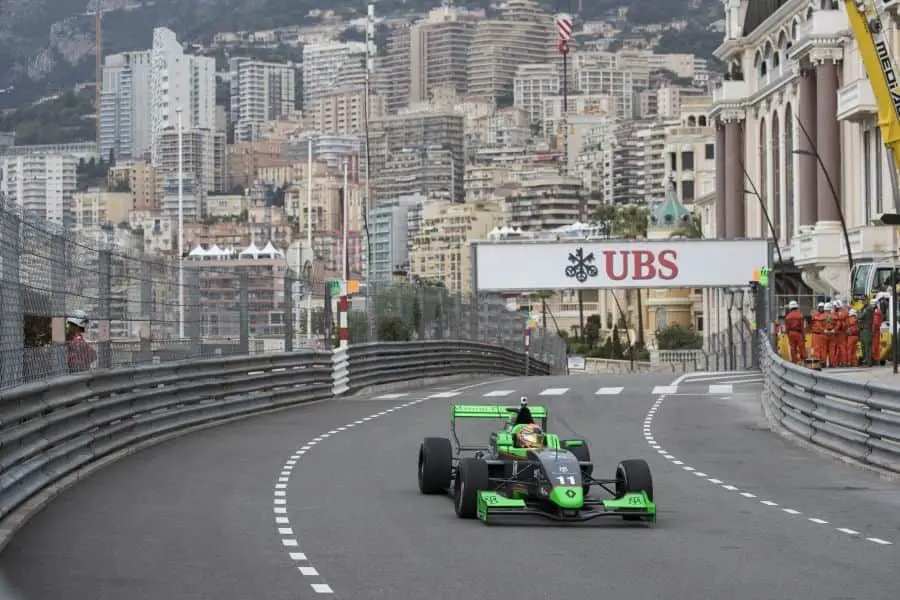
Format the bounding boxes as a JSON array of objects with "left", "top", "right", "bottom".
[{"left": 0, "top": 207, "right": 25, "bottom": 388}]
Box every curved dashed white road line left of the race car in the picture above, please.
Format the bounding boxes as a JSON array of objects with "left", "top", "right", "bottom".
[{"left": 272, "top": 379, "right": 502, "bottom": 594}]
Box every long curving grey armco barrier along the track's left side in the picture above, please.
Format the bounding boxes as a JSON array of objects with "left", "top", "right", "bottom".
[{"left": 0, "top": 341, "right": 550, "bottom": 519}]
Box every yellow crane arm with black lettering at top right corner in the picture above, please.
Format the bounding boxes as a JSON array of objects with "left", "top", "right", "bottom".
[{"left": 844, "top": 0, "right": 900, "bottom": 169}]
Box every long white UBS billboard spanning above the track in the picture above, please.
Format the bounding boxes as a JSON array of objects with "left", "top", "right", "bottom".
[{"left": 472, "top": 239, "right": 769, "bottom": 292}]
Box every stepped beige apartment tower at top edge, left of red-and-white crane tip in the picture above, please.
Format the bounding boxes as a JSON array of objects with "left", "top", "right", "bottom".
[{"left": 467, "top": 0, "right": 559, "bottom": 101}]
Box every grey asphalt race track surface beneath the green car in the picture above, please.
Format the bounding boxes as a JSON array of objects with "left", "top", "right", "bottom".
[{"left": 0, "top": 374, "right": 900, "bottom": 600}]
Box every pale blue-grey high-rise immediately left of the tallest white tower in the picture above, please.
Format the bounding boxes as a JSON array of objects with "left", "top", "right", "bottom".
[{"left": 99, "top": 50, "right": 152, "bottom": 162}]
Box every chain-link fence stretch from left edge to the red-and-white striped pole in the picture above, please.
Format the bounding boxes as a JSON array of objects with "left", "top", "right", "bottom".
[{"left": 0, "top": 206, "right": 327, "bottom": 388}]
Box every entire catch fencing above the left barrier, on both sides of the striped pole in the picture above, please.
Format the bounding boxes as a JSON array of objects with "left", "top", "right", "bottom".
[{"left": 0, "top": 206, "right": 565, "bottom": 389}]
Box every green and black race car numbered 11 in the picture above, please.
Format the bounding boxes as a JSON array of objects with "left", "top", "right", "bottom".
[{"left": 418, "top": 398, "right": 656, "bottom": 523}]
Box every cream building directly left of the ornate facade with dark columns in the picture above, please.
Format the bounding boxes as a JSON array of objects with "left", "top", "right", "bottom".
[{"left": 664, "top": 97, "right": 716, "bottom": 205}]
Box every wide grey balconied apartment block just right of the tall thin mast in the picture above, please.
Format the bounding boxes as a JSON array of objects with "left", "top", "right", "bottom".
[{"left": 369, "top": 105, "right": 465, "bottom": 202}]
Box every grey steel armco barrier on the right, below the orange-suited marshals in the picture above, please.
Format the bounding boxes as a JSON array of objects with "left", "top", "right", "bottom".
[{"left": 760, "top": 336, "right": 900, "bottom": 473}]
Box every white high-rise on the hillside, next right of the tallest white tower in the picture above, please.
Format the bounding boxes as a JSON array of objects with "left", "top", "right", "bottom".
[{"left": 228, "top": 57, "right": 296, "bottom": 142}]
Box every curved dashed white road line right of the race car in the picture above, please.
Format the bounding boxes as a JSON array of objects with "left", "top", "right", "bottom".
[{"left": 648, "top": 372, "right": 893, "bottom": 546}]
